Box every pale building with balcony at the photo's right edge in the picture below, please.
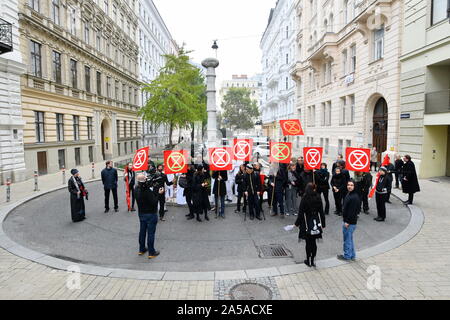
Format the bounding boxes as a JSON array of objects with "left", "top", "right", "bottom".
[{"left": 400, "top": 0, "right": 450, "bottom": 178}]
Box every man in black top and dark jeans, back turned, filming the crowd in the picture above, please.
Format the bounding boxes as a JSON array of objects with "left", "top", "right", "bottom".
[{"left": 135, "top": 174, "right": 164, "bottom": 259}]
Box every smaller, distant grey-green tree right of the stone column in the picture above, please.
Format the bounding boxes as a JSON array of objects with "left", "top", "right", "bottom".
[{"left": 221, "top": 88, "right": 260, "bottom": 130}]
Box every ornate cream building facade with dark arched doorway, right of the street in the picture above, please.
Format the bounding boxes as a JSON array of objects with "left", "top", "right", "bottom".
[{"left": 291, "top": 0, "right": 404, "bottom": 161}]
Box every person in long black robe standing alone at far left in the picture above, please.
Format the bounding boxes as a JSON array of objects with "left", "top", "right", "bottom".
[{"left": 68, "top": 169, "right": 87, "bottom": 223}]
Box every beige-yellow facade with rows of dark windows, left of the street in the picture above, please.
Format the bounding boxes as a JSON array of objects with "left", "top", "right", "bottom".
[{"left": 19, "top": 0, "right": 142, "bottom": 177}]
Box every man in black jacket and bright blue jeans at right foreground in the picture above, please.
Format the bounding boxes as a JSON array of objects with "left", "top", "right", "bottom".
[{"left": 337, "top": 180, "right": 361, "bottom": 261}]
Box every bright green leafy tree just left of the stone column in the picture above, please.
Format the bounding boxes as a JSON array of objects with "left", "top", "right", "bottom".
[{"left": 139, "top": 48, "right": 207, "bottom": 146}]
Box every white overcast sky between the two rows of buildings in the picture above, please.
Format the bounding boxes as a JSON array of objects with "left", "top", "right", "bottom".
[{"left": 153, "top": 0, "right": 276, "bottom": 86}]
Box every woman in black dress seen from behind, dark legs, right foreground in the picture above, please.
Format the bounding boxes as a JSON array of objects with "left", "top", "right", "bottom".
[{"left": 295, "top": 183, "right": 326, "bottom": 267}]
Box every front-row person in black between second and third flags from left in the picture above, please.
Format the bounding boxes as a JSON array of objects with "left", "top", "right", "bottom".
[{"left": 192, "top": 165, "right": 210, "bottom": 222}]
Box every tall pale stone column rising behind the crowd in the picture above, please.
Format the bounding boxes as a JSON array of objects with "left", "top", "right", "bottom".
[{"left": 202, "top": 58, "right": 219, "bottom": 148}]
